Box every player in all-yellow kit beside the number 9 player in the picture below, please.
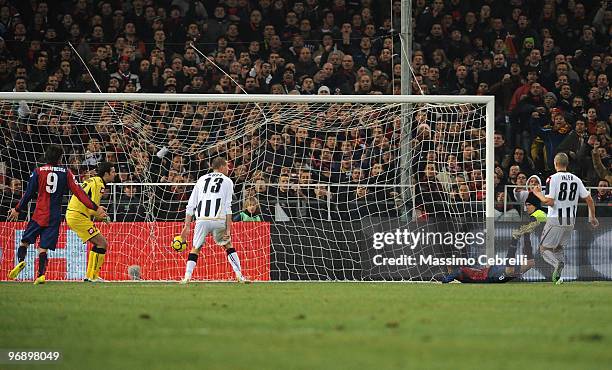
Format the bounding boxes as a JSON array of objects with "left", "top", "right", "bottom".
[{"left": 66, "top": 162, "right": 116, "bottom": 281}]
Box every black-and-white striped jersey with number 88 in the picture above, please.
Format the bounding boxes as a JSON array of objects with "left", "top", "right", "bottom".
[{"left": 546, "top": 172, "right": 589, "bottom": 226}]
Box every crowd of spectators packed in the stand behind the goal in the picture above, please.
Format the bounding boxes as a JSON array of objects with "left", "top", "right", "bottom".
[{"left": 0, "top": 0, "right": 612, "bottom": 219}]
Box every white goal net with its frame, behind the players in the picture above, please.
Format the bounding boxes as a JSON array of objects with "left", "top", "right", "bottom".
[{"left": 0, "top": 93, "right": 493, "bottom": 281}]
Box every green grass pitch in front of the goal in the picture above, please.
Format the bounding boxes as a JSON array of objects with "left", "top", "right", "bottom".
[{"left": 0, "top": 282, "right": 612, "bottom": 370}]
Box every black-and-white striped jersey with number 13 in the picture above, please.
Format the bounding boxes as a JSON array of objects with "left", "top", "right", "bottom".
[{"left": 186, "top": 172, "right": 234, "bottom": 220}]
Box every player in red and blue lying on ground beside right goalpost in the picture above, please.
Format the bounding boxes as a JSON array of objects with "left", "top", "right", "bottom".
[{"left": 442, "top": 193, "right": 546, "bottom": 283}]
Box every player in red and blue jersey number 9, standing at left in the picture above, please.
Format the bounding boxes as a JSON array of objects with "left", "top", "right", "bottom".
[{"left": 8, "top": 145, "right": 106, "bottom": 284}]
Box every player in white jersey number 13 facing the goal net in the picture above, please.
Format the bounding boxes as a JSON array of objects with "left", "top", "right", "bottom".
[{"left": 181, "top": 157, "right": 248, "bottom": 284}]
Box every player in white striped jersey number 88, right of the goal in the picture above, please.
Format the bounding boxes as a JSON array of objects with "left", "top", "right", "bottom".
[{"left": 533, "top": 153, "right": 599, "bottom": 284}]
